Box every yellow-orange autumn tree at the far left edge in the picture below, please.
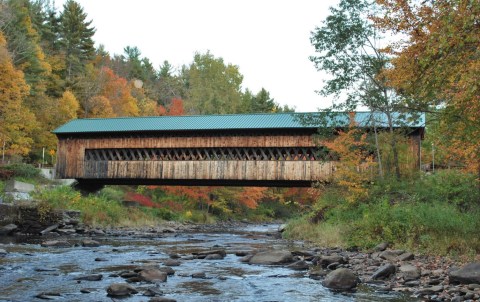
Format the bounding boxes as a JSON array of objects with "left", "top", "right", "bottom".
[{"left": 0, "top": 31, "right": 36, "bottom": 155}]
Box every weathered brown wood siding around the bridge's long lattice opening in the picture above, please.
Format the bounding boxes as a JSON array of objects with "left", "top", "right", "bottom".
[{"left": 57, "top": 134, "right": 320, "bottom": 180}]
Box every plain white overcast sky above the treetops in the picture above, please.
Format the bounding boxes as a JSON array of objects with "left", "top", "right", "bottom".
[{"left": 56, "top": 0, "right": 338, "bottom": 112}]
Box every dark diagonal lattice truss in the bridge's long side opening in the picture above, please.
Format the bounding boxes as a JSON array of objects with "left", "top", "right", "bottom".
[{"left": 85, "top": 147, "right": 331, "bottom": 161}]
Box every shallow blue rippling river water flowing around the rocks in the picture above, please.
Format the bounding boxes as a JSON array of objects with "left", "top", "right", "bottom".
[{"left": 0, "top": 225, "right": 414, "bottom": 302}]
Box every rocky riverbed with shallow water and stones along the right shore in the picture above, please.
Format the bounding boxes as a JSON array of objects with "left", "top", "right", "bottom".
[{"left": 0, "top": 223, "right": 480, "bottom": 301}]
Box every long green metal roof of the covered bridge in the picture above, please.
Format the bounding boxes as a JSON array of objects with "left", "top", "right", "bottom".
[{"left": 53, "top": 112, "right": 425, "bottom": 135}]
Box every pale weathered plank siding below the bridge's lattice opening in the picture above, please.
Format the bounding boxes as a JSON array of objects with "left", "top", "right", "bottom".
[{"left": 84, "top": 160, "right": 333, "bottom": 181}]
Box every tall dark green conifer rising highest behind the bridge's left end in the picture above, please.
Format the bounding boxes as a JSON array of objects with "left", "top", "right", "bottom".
[{"left": 60, "top": 0, "right": 95, "bottom": 81}]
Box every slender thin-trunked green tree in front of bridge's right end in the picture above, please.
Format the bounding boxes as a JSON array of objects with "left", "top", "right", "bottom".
[{"left": 310, "top": 0, "right": 416, "bottom": 178}]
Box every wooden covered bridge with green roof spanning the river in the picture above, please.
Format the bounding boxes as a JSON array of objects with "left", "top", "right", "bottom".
[{"left": 54, "top": 112, "right": 424, "bottom": 188}]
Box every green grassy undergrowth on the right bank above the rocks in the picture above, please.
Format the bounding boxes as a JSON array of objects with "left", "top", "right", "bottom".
[{"left": 285, "top": 171, "right": 480, "bottom": 256}]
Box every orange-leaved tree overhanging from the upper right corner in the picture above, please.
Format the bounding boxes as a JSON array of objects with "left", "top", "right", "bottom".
[{"left": 375, "top": 0, "right": 480, "bottom": 178}]
